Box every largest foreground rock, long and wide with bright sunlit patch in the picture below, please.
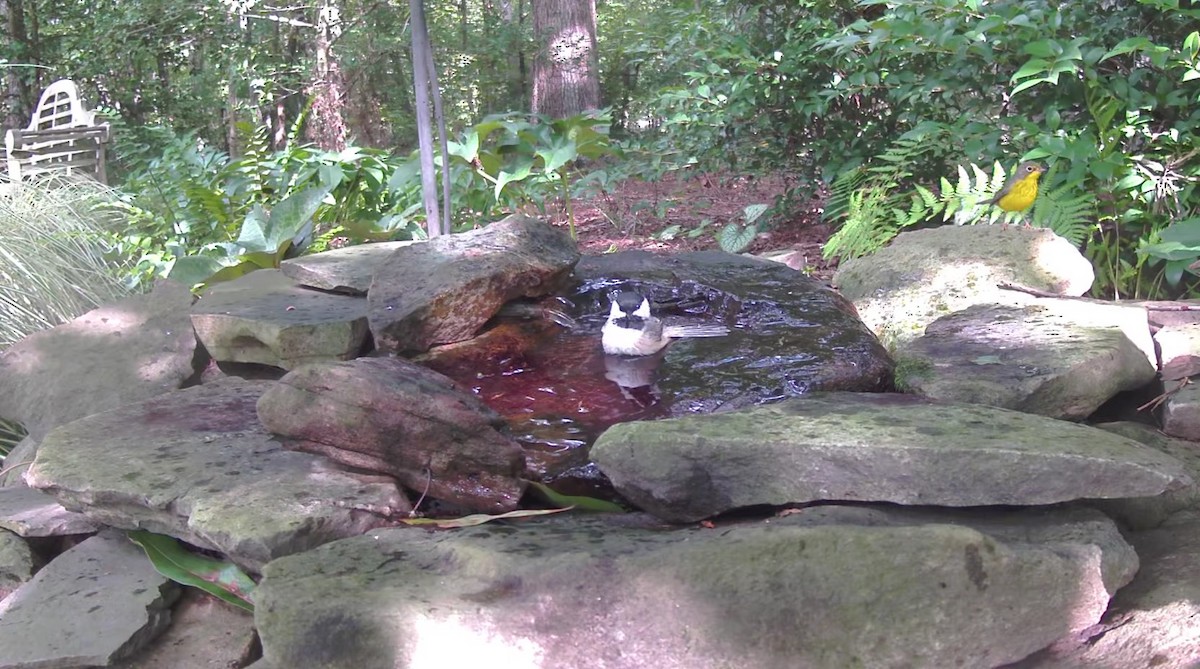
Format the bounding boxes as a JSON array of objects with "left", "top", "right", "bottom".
[{"left": 256, "top": 507, "right": 1136, "bottom": 669}]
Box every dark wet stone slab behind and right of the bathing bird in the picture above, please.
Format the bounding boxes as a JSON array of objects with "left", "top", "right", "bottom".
[{"left": 574, "top": 251, "right": 893, "bottom": 415}]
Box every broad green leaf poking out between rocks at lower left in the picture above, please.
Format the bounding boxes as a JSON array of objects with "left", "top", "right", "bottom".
[{"left": 128, "top": 530, "right": 257, "bottom": 611}]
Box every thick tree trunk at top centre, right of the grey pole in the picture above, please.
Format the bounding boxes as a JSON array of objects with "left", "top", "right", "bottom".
[{"left": 530, "top": 0, "right": 600, "bottom": 117}]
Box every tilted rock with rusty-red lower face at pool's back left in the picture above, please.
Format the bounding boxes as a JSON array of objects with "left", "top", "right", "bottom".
[{"left": 367, "top": 215, "right": 580, "bottom": 351}]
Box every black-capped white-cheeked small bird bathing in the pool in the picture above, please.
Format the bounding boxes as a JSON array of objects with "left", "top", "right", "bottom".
[{"left": 600, "top": 291, "right": 730, "bottom": 355}]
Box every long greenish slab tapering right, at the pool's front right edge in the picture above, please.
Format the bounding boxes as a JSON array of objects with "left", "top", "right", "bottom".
[{"left": 592, "top": 392, "right": 1190, "bottom": 523}]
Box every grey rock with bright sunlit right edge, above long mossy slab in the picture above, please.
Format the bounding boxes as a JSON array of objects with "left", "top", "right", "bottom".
[{"left": 896, "top": 300, "right": 1157, "bottom": 421}]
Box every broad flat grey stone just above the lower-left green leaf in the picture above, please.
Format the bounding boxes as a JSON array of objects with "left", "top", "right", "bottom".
[{"left": 25, "top": 378, "right": 409, "bottom": 571}]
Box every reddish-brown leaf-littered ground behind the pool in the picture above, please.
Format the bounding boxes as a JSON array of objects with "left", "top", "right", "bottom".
[{"left": 547, "top": 174, "right": 836, "bottom": 281}]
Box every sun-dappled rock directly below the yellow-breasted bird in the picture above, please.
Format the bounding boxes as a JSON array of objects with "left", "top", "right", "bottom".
[{"left": 833, "top": 225, "right": 1094, "bottom": 345}]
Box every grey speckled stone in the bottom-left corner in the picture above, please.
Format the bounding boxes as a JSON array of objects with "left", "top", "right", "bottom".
[{"left": 0, "top": 531, "right": 179, "bottom": 668}]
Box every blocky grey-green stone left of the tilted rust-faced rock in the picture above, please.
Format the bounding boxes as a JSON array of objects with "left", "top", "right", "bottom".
[{"left": 192, "top": 270, "right": 368, "bottom": 369}]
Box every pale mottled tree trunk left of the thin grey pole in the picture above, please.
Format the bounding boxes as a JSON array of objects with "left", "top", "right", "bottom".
[{"left": 306, "top": 0, "right": 347, "bottom": 151}]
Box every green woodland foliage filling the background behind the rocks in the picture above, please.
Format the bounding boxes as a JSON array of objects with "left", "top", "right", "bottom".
[{"left": 4, "top": 0, "right": 1200, "bottom": 297}]
